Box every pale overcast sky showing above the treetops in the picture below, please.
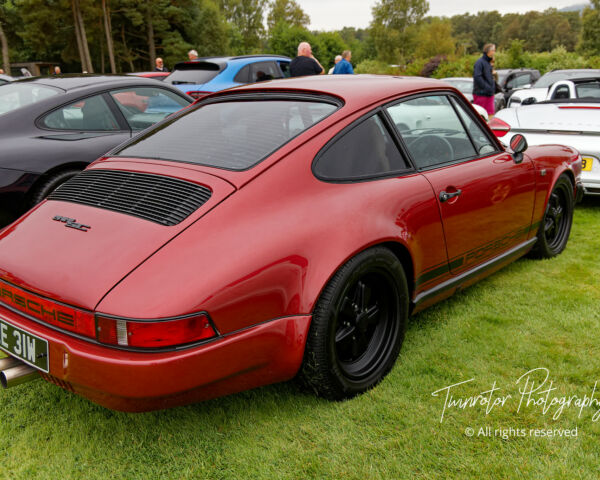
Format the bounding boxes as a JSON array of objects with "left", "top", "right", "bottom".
[{"left": 296, "top": 0, "right": 585, "bottom": 30}]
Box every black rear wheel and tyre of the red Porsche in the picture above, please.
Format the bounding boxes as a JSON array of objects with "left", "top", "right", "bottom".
[{"left": 299, "top": 247, "right": 408, "bottom": 400}]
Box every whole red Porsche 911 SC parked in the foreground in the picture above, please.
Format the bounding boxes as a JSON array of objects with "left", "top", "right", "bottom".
[{"left": 0, "top": 75, "right": 581, "bottom": 411}]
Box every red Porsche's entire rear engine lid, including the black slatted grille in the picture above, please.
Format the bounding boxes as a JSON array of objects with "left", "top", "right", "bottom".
[{"left": 0, "top": 161, "right": 235, "bottom": 309}]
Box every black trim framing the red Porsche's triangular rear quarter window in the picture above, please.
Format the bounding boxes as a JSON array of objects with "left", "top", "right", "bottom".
[{"left": 310, "top": 109, "right": 416, "bottom": 184}]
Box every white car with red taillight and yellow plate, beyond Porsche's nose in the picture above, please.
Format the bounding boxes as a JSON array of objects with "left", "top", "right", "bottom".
[{"left": 489, "top": 98, "right": 600, "bottom": 195}]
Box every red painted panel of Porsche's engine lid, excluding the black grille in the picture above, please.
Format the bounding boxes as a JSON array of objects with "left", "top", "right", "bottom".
[{"left": 0, "top": 161, "right": 235, "bottom": 310}]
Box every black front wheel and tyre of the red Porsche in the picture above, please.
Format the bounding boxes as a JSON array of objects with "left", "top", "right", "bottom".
[{"left": 530, "top": 175, "right": 574, "bottom": 258}]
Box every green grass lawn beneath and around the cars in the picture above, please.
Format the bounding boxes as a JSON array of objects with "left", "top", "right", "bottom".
[{"left": 0, "top": 199, "right": 600, "bottom": 480}]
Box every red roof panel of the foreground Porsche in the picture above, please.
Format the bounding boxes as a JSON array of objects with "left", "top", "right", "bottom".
[{"left": 199, "top": 74, "right": 458, "bottom": 108}]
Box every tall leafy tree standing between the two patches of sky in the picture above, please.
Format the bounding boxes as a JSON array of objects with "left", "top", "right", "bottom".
[{"left": 371, "top": 0, "right": 429, "bottom": 63}]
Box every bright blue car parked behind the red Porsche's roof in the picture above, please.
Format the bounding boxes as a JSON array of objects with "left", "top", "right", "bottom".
[{"left": 164, "top": 55, "right": 291, "bottom": 99}]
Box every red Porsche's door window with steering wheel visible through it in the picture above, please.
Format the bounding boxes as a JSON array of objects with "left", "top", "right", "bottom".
[{"left": 387, "top": 95, "right": 477, "bottom": 168}]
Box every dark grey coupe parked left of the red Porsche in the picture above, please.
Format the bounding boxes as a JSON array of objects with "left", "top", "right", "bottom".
[{"left": 0, "top": 75, "right": 193, "bottom": 226}]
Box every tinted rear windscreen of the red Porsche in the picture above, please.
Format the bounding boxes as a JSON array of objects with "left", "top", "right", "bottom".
[{"left": 113, "top": 100, "right": 338, "bottom": 170}]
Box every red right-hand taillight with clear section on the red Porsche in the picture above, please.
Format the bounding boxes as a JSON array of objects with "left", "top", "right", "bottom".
[{"left": 96, "top": 313, "right": 216, "bottom": 348}]
